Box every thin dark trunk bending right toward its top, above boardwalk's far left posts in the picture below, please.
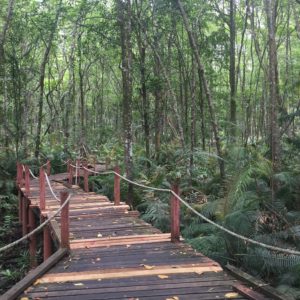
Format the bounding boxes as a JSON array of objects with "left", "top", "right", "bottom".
[{"left": 35, "top": 0, "right": 62, "bottom": 158}]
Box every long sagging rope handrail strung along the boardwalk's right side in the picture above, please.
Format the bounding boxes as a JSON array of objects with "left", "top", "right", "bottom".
[{"left": 83, "top": 167, "right": 300, "bottom": 255}]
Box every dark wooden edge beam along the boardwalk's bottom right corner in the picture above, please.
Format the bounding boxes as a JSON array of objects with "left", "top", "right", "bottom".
[{"left": 225, "top": 264, "right": 294, "bottom": 300}]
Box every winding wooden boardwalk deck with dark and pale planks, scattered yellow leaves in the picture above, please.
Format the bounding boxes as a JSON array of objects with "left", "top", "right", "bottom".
[{"left": 3, "top": 168, "right": 271, "bottom": 300}]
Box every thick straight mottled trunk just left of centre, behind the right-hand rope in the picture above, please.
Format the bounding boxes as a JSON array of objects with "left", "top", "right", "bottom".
[{"left": 117, "top": 0, "right": 133, "bottom": 207}]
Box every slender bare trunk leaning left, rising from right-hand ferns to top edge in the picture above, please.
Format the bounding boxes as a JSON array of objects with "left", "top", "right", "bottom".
[{"left": 177, "top": 0, "right": 225, "bottom": 179}]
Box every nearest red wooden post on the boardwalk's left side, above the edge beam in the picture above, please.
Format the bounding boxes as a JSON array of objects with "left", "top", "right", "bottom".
[{"left": 60, "top": 191, "right": 70, "bottom": 249}]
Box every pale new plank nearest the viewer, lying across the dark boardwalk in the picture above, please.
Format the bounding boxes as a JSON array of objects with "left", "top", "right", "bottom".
[{"left": 39, "top": 265, "right": 223, "bottom": 283}]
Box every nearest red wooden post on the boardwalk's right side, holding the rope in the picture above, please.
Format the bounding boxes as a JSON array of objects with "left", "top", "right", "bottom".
[{"left": 171, "top": 184, "right": 180, "bottom": 243}]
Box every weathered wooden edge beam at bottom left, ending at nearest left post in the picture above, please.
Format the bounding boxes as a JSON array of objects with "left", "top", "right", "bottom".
[{"left": 1, "top": 249, "right": 68, "bottom": 300}]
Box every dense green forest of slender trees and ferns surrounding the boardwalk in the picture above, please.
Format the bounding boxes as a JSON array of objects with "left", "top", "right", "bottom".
[{"left": 0, "top": 0, "right": 300, "bottom": 296}]
